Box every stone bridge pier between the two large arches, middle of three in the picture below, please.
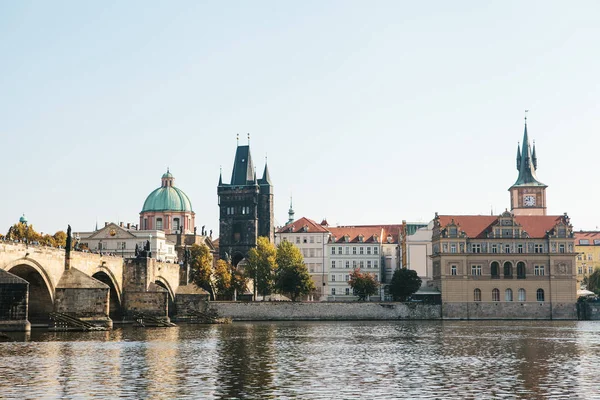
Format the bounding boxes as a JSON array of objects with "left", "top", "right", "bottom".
[{"left": 54, "top": 268, "right": 112, "bottom": 329}]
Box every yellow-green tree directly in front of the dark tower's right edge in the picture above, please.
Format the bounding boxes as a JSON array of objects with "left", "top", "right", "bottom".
[{"left": 245, "top": 236, "right": 277, "bottom": 301}]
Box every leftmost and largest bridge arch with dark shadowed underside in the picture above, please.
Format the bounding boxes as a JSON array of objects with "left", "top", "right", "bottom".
[{"left": 3, "top": 258, "right": 55, "bottom": 324}]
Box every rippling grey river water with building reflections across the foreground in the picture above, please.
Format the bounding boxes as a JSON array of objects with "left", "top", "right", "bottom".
[{"left": 0, "top": 321, "right": 600, "bottom": 399}]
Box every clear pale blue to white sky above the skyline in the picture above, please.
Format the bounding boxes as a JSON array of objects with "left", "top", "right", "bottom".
[{"left": 0, "top": 0, "right": 600, "bottom": 235}]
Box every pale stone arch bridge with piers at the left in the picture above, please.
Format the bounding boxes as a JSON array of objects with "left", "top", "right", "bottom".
[{"left": 0, "top": 242, "right": 207, "bottom": 331}]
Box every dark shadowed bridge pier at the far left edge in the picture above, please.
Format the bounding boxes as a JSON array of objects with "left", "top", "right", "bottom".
[{"left": 0, "top": 269, "right": 31, "bottom": 332}]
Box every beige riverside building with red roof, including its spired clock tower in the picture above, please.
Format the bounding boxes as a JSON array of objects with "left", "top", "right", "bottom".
[{"left": 431, "top": 121, "right": 577, "bottom": 319}]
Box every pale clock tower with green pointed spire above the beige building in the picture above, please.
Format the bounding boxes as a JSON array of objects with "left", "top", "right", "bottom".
[{"left": 508, "top": 117, "right": 548, "bottom": 215}]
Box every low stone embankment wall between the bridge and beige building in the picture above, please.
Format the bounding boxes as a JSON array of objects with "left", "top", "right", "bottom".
[{"left": 209, "top": 301, "right": 441, "bottom": 321}]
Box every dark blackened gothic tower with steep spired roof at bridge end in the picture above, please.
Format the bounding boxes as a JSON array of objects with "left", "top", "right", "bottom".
[{"left": 217, "top": 138, "right": 275, "bottom": 265}]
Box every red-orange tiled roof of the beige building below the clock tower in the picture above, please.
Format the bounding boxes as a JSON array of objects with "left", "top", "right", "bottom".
[{"left": 439, "top": 215, "right": 563, "bottom": 238}]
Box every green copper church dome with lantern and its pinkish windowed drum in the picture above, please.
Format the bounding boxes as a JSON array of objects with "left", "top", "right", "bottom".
[{"left": 140, "top": 168, "right": 196, "bottom": 234}]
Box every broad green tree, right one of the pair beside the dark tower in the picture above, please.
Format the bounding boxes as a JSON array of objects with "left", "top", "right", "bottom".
[{"left": 275, "top": 241, "right": 315, "bottom": 301}]
